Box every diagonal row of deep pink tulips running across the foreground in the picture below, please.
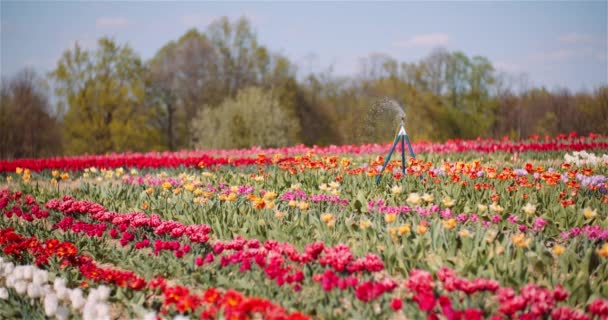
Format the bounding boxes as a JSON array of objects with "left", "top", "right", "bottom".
[{"left": 4, "top": 188, "right": 605, "bottom": 319}]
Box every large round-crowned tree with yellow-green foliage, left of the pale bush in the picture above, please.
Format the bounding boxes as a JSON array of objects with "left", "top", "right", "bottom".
[{"left": 51, "top": 38, "right": 163, "bottom": 154}]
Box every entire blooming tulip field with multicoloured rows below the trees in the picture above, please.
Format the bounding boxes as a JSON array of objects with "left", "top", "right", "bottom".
[{"left": 0, "top": 133, "right": 608, "bottom": 320}]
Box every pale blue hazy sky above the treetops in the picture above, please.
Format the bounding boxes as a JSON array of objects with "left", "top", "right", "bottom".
[{"left": 0, "top": 0, "right": 608, "bottom": 91}]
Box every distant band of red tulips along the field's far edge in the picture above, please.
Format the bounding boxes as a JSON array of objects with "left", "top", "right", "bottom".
[{"left": 0, "top": 133, "right": 608, "bottom": 172}]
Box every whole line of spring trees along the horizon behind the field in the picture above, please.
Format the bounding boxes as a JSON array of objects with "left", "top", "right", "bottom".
[{"left": 0, "top": 18, "right": 608, "bottom": 158}]
